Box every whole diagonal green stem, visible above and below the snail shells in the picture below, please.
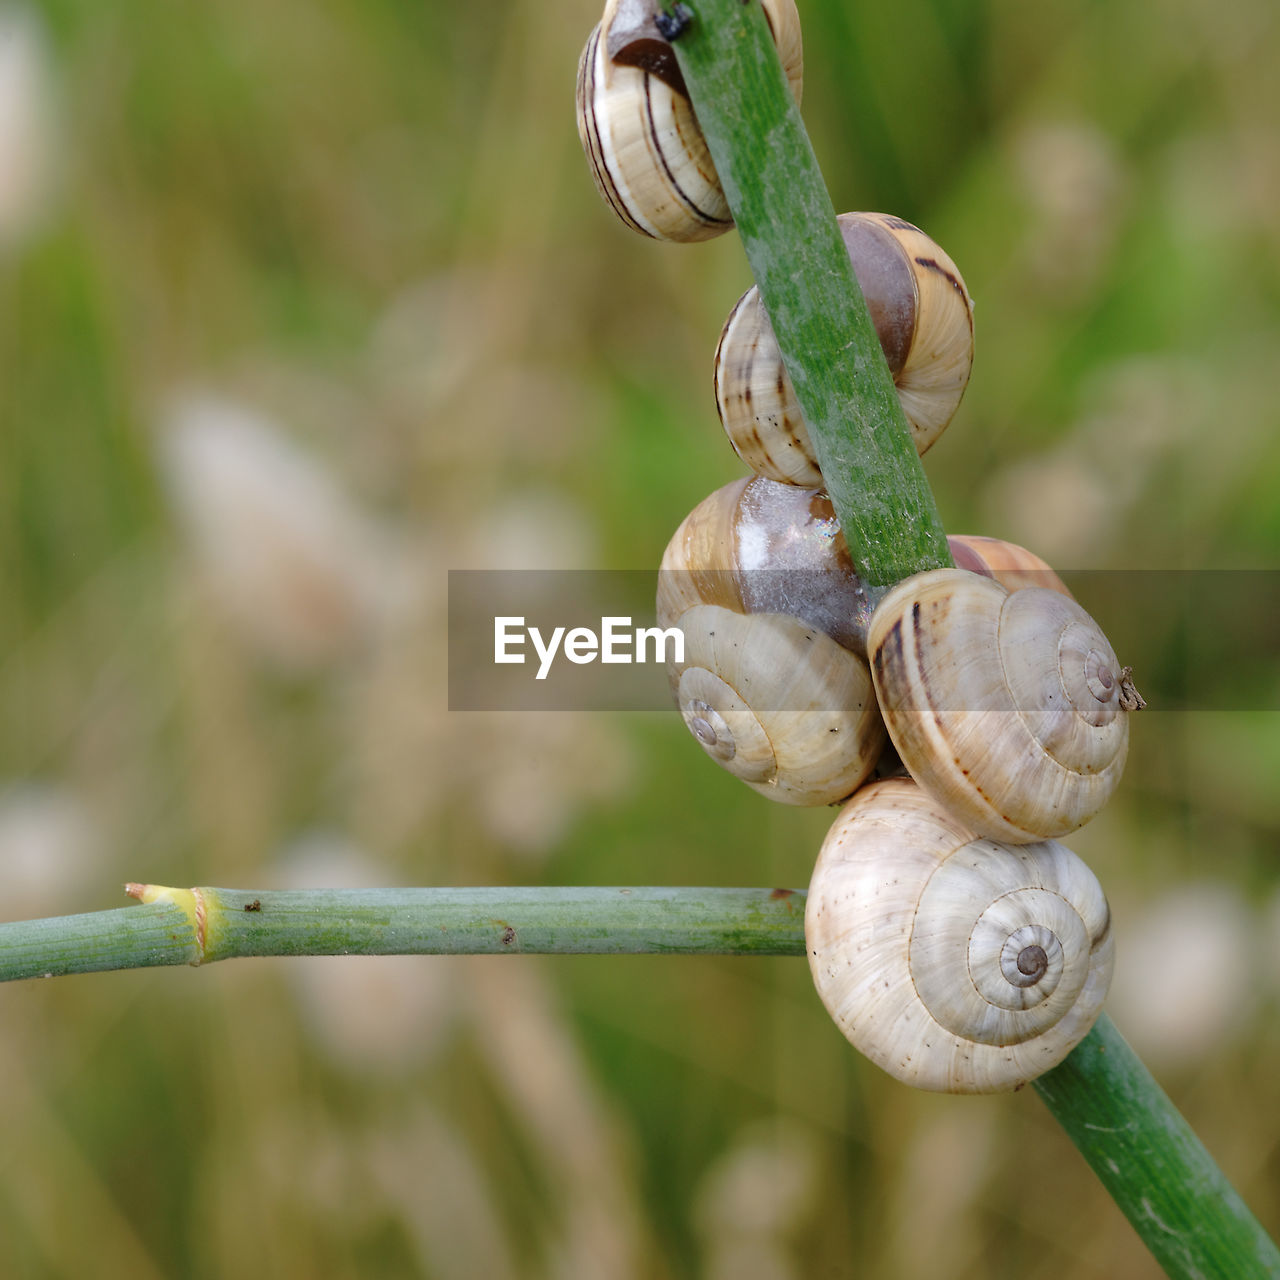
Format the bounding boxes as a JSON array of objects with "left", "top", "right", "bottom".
[{"left": 673, "top": 0, "right": 1280, "bottom": 1280}]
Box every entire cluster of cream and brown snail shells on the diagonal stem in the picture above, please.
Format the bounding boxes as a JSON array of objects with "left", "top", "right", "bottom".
[{"left": 577, "top": 0, "right": 1142, "bottom": 1092}]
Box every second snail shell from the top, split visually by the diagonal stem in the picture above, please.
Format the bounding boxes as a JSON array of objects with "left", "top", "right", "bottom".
[{"left": 714, "top": 214, "right": 973, "bottom": 486}]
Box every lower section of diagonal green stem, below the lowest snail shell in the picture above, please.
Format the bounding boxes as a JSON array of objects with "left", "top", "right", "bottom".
[{"left": 1036, "top": 1014, "right": 1280, "bottom": 1280}]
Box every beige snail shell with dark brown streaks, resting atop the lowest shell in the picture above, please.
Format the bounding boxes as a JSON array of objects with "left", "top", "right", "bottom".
[{"left": 867, "top": 568, "right": 1129, "bottom": 844}]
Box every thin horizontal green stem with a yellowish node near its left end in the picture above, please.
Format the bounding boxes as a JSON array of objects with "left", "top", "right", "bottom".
[{"left": 0, "top": 884, "right": 804, "bottom": 980}]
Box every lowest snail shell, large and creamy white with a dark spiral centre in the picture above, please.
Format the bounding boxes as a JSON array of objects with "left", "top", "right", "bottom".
[{"left": 805, "top": 778, "right": 1114, "bottom": 1093}]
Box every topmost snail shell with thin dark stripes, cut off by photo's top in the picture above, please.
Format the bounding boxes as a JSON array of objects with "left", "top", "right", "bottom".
[{"left": 577, "top": 0, "right": 804, "bottom": 242}]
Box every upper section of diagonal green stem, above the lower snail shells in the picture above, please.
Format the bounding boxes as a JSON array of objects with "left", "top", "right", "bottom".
[{"left": 675, "top": 0, "right": 954, "bottom": 594}]
